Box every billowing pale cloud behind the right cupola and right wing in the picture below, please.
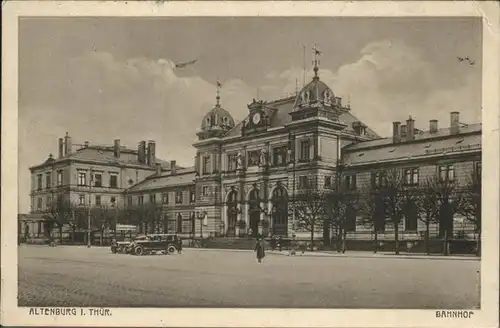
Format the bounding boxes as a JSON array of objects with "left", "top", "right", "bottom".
[{"left": 262, "top": 40, "right": 481, "bottom": 135}]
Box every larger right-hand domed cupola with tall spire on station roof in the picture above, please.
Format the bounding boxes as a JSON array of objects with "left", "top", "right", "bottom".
[{"left": 290, "top": 47, "right": 349, "bottom": 120}]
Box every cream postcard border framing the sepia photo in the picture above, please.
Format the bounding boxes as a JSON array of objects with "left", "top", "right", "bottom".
[{"left": 1, "top": 1, "right": 500, "bottom": 327}]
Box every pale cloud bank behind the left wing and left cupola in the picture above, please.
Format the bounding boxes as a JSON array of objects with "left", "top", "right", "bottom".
[{"left": 19, "top": 52, "right": 251, "bottom": 208}]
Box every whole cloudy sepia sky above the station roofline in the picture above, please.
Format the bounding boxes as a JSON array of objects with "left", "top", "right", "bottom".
[{"left": 18, "top": 17, "right": 482, "bottom": 212}]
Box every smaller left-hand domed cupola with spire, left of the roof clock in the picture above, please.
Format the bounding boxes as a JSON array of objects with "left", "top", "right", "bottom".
[{"left": 198, "top": 81, "right": 234, "bottom": 140}]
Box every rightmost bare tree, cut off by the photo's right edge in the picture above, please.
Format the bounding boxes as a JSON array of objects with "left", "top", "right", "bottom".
[{"left": 458, "top": 172, "right": 482, "bottom": 256}]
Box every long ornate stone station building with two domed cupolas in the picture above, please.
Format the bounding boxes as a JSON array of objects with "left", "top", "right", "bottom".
[{"left": 21, "top": 65, "right": 481, "bottom": 238}]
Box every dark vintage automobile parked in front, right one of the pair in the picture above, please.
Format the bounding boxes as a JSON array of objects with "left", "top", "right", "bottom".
[{"left": 129, "top": 234, "right": 182, "bottom": 256}]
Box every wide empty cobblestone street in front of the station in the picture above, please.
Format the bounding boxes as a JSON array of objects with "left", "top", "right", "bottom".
[{"left": 19, "top": 246, "right": 480, "bottom": 309}]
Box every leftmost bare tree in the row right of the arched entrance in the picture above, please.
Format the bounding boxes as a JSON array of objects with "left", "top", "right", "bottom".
[{"left": 294, "top": 186, "right": 327, "bottom": 249}]
